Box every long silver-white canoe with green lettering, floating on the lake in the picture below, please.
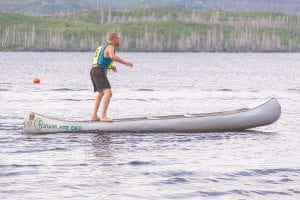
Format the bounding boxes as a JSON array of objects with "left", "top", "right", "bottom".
[{"left": 23, "top": 98, "right": 281, "bottom": 133}]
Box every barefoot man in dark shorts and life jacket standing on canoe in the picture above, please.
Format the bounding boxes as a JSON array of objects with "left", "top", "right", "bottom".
[{"left": 90, "top": 33, "right": 133, "bottom": 122}]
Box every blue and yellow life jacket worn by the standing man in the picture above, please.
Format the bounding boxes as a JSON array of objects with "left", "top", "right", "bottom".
[{"left": 93, "top": 43, "right": 113, "bottom": 71}]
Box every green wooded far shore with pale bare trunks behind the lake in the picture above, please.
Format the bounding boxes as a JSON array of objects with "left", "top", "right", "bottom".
[{"left": 0, "top": 8, "right": 300, "bottom": 52}]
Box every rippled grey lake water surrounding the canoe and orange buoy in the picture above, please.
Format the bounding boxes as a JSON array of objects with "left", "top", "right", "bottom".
[{"left": 0, "top": 52, "right": 300, "bottom": 200}]
